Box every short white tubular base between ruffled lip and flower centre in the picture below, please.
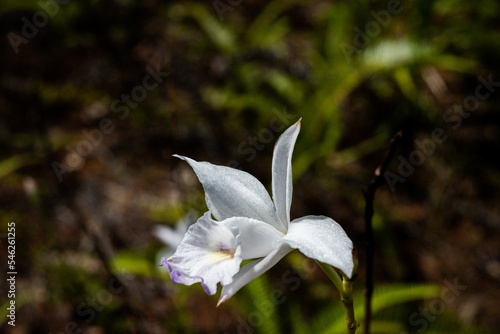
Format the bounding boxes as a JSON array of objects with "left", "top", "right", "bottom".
[{"left": 220, "top": 217, "right": 284, "bottom": 260}]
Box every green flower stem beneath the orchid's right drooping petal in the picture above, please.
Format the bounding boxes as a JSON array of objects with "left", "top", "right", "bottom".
[{"left": 316, "top": 261, "right": 358, "bottom": 334}]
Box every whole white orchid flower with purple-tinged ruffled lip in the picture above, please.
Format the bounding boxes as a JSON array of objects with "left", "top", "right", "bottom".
[{"left": 161, "top": 120, "right": 354, "bottom": 305}]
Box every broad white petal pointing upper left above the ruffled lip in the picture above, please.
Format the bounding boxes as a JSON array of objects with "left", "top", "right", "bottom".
[{"left": 174, "top": 155, "right": 286, "bottom": 232}]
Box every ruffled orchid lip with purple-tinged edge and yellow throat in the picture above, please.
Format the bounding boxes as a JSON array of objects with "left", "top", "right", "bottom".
[{"left": 167, "top": 212, "right": 242, "bottom": 295}]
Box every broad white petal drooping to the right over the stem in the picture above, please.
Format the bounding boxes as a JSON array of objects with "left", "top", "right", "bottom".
[{"left": 283, "top": 216, "right": 354, "bottom": 278}]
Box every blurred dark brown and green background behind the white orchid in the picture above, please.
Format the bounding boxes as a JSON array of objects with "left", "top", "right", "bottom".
[{"left": 0, "top": 0, "right": 500, "bottom": 334}]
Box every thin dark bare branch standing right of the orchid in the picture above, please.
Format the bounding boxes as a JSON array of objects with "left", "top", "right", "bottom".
[{"left": 363, "top": 130, "right": 403, "bottom": 334}]
